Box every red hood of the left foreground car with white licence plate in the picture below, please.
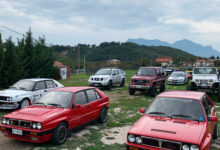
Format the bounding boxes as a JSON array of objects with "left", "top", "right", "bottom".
[{"left": 4, "top": 105, "right": 67, "bottom": 122}]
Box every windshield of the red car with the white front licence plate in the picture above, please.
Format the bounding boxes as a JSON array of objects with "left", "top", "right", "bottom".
[{"left": 34, "top": 91, "right": 73, "bottom": 108}]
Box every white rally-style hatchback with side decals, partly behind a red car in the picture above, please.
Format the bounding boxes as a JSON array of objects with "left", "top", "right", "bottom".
[{"left": 0, "top": 78, "right": 63, "bottom": 109}]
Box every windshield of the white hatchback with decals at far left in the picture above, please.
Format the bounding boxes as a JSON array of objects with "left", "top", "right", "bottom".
[{"left": 10, "top": 80, "right": 35, "bottom": 91}]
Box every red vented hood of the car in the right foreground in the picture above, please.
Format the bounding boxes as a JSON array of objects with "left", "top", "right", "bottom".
[{"left": 129, "top": 116, "right": 205, "bottom": 144}]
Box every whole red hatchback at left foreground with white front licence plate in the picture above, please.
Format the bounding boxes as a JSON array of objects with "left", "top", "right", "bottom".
[{"left": 0, "top": 87, "right": 109, "bottom": 144}]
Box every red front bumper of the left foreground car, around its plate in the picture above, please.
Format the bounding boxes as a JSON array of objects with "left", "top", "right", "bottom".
[{"left": 0, "top": 124, "right": 53, "bottom": 143}]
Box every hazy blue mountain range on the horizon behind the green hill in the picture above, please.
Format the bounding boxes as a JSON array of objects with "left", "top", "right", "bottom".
[{"left": 127, "top": 38, "right": 220, "bottom": 57}]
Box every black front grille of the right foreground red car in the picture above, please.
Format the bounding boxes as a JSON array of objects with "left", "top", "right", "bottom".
[{"left": 142, "top": 137, "right": 182, "bottom": 150}]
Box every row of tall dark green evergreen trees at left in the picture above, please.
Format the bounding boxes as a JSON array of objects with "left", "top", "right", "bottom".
[{"left": 0, "top": 30, "right": 56, "bottom": 88}]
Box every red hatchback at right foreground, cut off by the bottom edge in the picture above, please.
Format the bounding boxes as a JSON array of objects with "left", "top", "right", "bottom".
[{"left": 126, "top": 91, "right": 218, "bottom": 150}]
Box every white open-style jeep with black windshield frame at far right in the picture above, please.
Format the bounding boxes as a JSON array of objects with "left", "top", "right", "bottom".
[{"left": 187, "top": 67, "right": 220, "bottom": 99}]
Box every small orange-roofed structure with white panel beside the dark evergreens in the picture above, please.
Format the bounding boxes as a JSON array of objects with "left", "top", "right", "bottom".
[{"left": 53, "top": 61, "right": 70, "bottom": 80}]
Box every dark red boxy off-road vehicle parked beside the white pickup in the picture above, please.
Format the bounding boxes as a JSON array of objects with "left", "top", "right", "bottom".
[{"left": 129, "top": 67, "right": 166, "bottom": 96}]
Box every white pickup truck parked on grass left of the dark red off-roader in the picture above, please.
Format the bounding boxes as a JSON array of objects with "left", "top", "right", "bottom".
[{"left": 88, "top": 68, "right": 126, "bottom": 90}]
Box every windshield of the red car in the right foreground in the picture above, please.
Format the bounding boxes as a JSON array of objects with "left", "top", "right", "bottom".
[{"left": 146, "top": 97, "right": 205, "bottom": 122}]
